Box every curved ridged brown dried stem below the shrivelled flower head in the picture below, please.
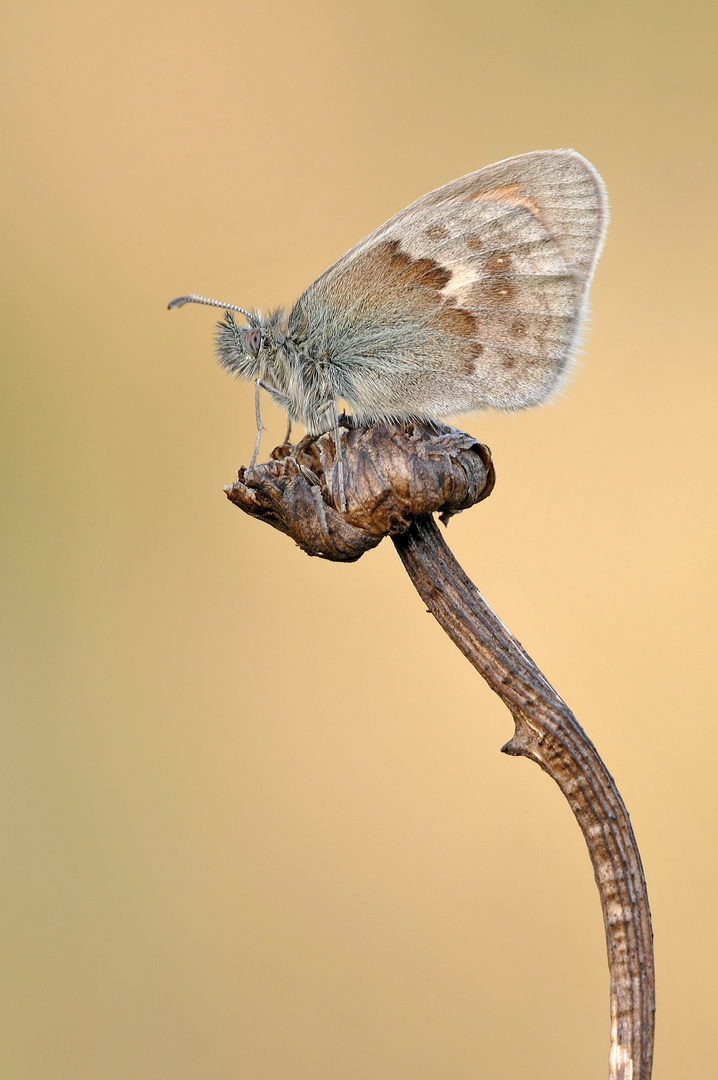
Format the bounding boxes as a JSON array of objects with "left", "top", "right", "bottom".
[{"left": 392, "top": 515, "right": 655, "bottom": 1080}]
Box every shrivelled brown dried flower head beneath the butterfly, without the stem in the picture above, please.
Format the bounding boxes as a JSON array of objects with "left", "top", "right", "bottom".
[{"left": 225, "top": 422, "right": 495, "bottom": 562}]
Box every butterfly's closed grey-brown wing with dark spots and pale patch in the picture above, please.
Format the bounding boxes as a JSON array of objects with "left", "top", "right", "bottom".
[{"left": 288, "top": 150, "right": 608, "bottom": 422}]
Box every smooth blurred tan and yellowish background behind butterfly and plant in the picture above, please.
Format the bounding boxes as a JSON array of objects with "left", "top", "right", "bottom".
[{"left": 0, "top": 0, "right": 718, "bottom": 1080}]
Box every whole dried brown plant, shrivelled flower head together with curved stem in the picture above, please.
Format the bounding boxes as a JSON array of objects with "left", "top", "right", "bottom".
[{"left": 225, "top": 422, "right": 654, "bottom": 1080}]
